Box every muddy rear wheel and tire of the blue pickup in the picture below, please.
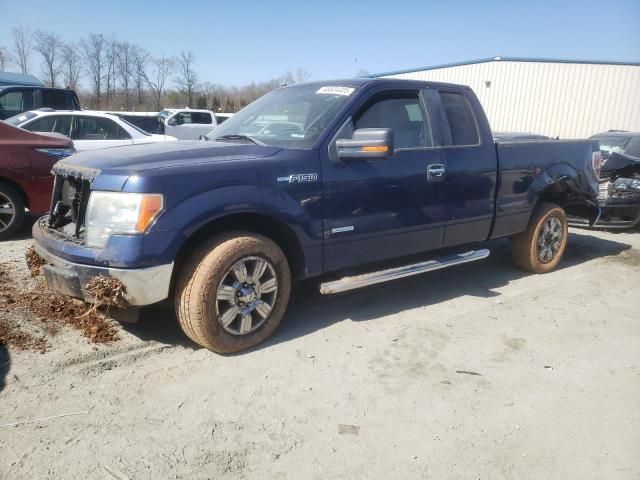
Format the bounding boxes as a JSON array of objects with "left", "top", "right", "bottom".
[{"left": 511, "top": 202, "right": 569, "bottom": 273}]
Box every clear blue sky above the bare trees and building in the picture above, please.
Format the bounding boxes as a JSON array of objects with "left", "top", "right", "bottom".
[{"left": 0, "top": 0, "right": 640, "bottom": 85}]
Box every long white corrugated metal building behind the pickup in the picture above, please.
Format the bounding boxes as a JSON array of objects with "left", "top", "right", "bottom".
[{"left": 374, "top": 57, "right": 640, "bottom": 138}]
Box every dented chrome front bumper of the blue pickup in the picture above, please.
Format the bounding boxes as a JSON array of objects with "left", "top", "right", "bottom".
[{"left": 34, "top": 227, "right": 173, "bottom": 307}]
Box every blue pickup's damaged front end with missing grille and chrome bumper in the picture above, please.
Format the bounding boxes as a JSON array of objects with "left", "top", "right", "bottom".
[{"left": 31, "top": 162, "right": 173, "bottom": 309}]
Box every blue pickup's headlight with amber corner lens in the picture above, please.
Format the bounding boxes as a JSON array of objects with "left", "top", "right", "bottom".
[{"left": 85, "top": 191, "right": 164, "bottom": 248}]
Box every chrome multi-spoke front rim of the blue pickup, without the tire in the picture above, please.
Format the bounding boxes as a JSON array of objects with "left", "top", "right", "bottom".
[{"left": 216, "top": 257, "right": 278, "bottom": 335}]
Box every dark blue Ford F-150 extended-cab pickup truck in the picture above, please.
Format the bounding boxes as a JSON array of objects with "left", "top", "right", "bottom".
[{"left": 33, "top": 79, "right": 600, "bottom": 352}]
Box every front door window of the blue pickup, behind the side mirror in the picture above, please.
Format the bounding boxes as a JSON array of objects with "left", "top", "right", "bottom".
[{"left": 354, "top": 94, "right": 433, "bottom": 150}]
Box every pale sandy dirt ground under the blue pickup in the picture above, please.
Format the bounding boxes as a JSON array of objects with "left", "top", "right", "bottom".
[{"left": 0, "top": 218, "right": 640, "bottom": 480}]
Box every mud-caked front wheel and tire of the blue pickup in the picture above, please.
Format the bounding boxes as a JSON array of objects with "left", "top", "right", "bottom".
[{"left": 175, "top": 232, "right": 291, "bottom": 353}]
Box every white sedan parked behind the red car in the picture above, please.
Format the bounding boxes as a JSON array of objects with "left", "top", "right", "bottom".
[{"left": 6, "top": 109, "right": 176, "bottom": 152}]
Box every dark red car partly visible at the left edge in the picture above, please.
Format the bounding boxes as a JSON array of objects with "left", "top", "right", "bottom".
[{"left": 0, "top": 121, "right": 75, "bottom": 240}]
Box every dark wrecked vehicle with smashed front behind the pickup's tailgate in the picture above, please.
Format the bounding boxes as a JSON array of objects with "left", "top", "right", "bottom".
[{"left": 570, "top": 153, "right": 640, "bottom": 229}]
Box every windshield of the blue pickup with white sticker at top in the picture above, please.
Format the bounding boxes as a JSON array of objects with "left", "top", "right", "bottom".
[{"left": 206, "top": 85, "right": 355, "bottom": 150}]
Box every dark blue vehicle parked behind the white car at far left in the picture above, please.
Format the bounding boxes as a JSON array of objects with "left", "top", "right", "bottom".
[{"left": 0, "top": 85, "right": 80, "bottom": 120}]
